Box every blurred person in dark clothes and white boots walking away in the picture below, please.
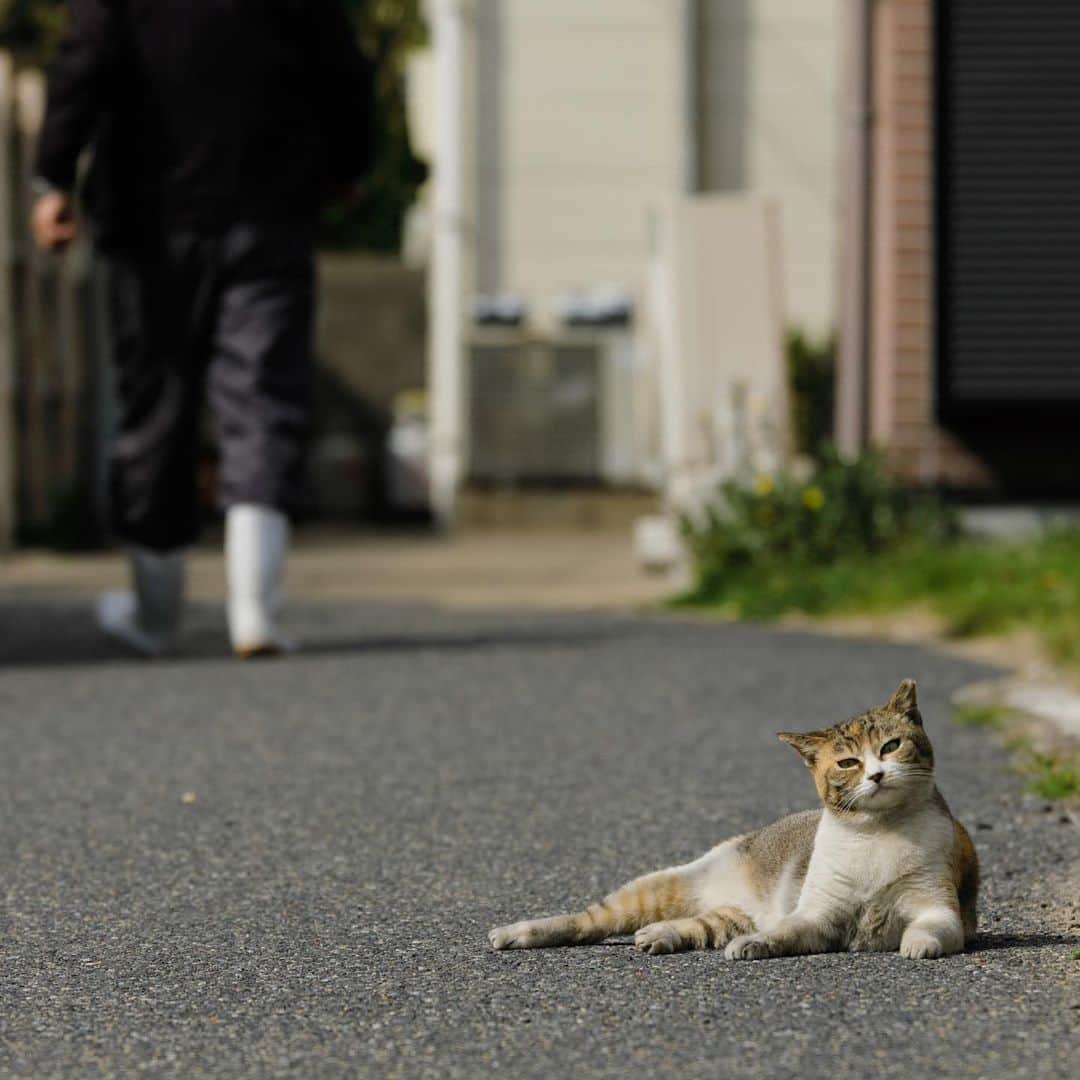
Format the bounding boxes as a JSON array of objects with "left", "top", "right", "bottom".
[{"left": 32, "top": 0, "right": 373, "bottom": 657}]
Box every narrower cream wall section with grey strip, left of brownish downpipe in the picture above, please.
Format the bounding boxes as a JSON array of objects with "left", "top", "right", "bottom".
[{"left": 701, "top": 0, "right": 846, "bottom": 333}]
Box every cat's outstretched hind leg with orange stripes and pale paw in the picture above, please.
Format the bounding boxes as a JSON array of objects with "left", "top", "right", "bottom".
[{"left": 488, "top": 867, "right": 692, "bottom": 949}]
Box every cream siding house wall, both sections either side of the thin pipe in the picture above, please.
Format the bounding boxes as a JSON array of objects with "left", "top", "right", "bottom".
[{"left": 476, "top": 0, "right": 845, "bottom": 332}]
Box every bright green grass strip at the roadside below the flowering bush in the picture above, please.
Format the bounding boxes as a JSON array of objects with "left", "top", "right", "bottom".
[{"left": 677, "top": 529, "right": 1080, "bottom": 664}]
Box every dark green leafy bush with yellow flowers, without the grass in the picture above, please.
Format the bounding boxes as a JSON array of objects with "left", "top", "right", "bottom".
[{"left": 684, "top": 446, "right": 956, "bottom": 596}]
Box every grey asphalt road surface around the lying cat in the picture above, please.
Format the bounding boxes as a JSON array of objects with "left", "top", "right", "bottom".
[{"left": 0, "top": 602, "right": 1080, "bottom": 1078}]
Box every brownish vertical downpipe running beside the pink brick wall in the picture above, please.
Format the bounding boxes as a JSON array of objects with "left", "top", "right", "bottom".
[{"left": 835, "top": 0, "right": 875, "bottom": 458}]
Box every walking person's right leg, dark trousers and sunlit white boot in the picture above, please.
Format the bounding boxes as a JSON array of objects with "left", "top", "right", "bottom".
[{"left": 210, "top": 227, "right": 314, "bottom": 657}]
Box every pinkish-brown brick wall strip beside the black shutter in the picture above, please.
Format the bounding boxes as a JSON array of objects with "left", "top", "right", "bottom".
[{"left": 869, "top": 0, "right": 990, "bottom": 487}]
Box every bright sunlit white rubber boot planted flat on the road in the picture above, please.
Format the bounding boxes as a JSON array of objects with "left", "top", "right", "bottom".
[{"left": 225, "top": 502, "right": 295, "bottom": 660}]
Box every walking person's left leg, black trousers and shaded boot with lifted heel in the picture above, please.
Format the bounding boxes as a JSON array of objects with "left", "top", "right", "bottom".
[{"left": 97, "top": 245, "right": 213, "bottom": 656}]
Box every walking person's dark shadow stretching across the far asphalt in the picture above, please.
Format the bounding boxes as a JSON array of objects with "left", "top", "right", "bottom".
[{"left": 0, "top": 603, "right": 643, "bottom": 669}]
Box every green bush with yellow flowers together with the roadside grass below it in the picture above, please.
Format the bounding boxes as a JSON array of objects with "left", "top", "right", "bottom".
[{"left": 680, "top": 446, "right": 1080, "bottom": 665}]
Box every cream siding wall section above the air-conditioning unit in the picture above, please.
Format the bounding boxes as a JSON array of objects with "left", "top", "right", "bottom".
[{"left": 476, "top": 0, "right": 683, "bottom": 314}]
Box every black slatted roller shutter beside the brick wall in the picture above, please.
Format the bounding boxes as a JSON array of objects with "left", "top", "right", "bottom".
[{"left": 936, "top": 0, "right": 1080, "bottom": 421}]
